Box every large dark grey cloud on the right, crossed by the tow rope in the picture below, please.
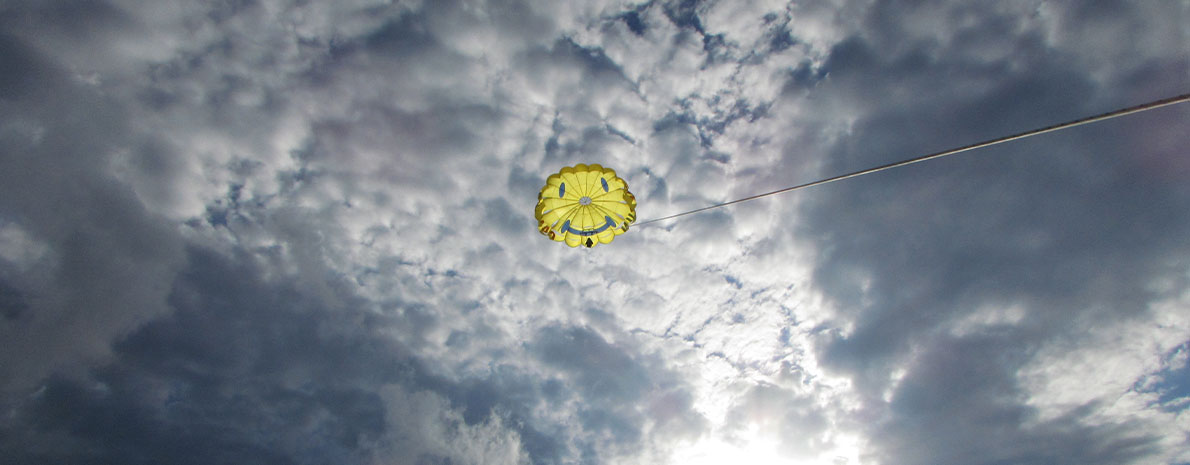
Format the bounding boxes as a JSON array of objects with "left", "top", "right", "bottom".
[{"left": 791, "top": 2, "right": 1190, "bottom": 463}]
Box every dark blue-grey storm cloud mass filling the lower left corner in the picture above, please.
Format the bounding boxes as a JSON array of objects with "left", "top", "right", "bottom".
[{"left": 0, "top": 250, "right": 397, "bottom": 464}]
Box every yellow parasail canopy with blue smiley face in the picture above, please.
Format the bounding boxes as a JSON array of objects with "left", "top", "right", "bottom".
[{"left": 533, "top": 164, "right": 637, "bottom": 247}]
